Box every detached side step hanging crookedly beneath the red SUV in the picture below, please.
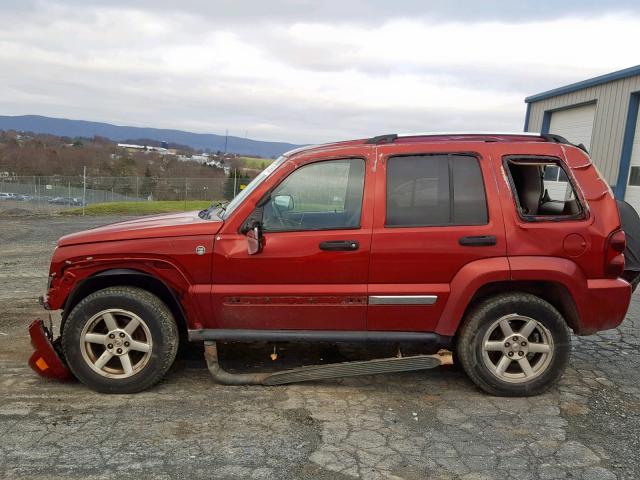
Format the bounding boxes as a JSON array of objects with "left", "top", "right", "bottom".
[{"left": 205, "top": 342, "right": 453, "bottom": 385}]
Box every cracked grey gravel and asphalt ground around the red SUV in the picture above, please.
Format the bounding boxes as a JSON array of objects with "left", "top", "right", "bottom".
[{"left": 0, "top": 217, "right": 640, "bottom": 480}]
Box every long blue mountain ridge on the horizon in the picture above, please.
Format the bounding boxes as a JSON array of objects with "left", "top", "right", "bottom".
[{"left": 0, "top": 115, "right": 300, "bottom": 158}]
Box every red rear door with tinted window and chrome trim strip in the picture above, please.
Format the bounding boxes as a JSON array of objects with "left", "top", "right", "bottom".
[{"left": 367, "top": 144, "right": 506, "bottom": 331}]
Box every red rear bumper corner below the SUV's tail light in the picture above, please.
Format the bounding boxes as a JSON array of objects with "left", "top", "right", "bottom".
[{"left": 577, "top": 278, "right": 632, "bottom": 335}]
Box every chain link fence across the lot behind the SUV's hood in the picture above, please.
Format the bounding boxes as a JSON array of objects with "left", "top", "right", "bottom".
[{"left": 0, "top": 175, "right": 227, "bottom": 213}]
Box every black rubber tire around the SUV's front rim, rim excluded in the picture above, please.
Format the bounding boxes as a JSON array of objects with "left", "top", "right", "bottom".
[{"left": 62, "top": 286, "right": 178, "bottom": 393}]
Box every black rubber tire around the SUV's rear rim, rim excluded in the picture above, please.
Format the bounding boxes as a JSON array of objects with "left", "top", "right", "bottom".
[{"left": 456, "top": 293, "right": 571, "bottom": 397}]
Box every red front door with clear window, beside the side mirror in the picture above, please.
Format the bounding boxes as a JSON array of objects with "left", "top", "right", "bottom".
[{"left": 212, "top": 152, "right": 374, "bottom": 330}]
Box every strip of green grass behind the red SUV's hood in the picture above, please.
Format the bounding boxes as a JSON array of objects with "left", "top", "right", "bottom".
[{"left": 61, "top": 200, "right": 211, "bottom": 215}]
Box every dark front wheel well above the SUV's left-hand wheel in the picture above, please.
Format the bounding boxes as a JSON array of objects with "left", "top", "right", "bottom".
[{"left": 60, "top": 269, "right": 187, "bottom": 344}]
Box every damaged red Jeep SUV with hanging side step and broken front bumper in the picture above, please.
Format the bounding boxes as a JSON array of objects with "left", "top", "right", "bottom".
[{"left": 31, "top": 133, "right": 631, "bottom": 395}]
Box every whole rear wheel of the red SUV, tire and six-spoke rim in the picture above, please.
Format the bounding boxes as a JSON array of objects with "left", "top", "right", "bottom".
[{"left": 456, "top": 293, "right": 571, "bottom": 396}]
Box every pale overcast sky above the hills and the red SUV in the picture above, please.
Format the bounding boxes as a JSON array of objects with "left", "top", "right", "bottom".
[{"left": 0, "top": 0, "right": 640, "bottom": 143}]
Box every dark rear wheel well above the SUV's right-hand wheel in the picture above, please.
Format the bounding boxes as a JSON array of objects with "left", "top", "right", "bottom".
[{"left": 464, "top": 281, "right": 580, "bottom": 332}]
